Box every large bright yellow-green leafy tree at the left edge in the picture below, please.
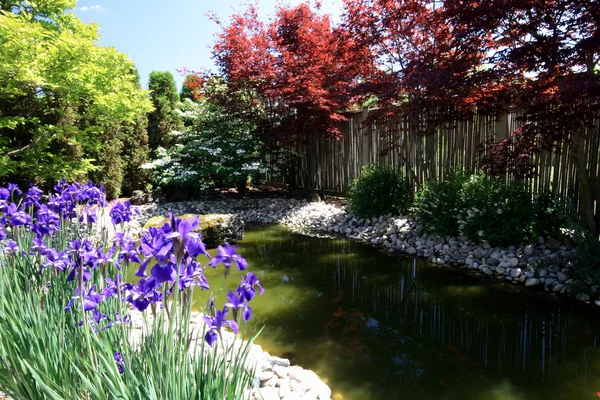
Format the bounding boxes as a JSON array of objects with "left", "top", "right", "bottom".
[{"left": 0, "top": 0, "right": 152, "bottom": 196}]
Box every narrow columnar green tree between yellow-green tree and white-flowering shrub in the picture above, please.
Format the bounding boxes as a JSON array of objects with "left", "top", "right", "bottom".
[{"left": 148, "top": 71, "right": 182, "bottom": 152}]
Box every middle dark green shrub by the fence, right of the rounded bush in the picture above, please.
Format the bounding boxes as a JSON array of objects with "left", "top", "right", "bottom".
[{"left": 415, "top": 172, "right": 469, "bottom": 236}]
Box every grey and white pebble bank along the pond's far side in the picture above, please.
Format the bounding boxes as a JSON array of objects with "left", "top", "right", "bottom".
[{"left": 127, "top": 198, "right": 600, "bottom": 306}]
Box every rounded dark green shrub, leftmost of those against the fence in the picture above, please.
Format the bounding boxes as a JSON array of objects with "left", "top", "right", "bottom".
[{"left": 348, "top": 165, "right": 412, "bottom": 218}]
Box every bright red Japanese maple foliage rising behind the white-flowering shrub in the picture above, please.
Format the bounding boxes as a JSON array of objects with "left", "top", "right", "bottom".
[{"left": 213, "top": 3, "right": 368, "bottom": 145}]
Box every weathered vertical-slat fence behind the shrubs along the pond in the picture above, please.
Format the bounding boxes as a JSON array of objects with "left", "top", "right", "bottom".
[{"left": 266, "top": 110, "right": 600, "bottom": 221}]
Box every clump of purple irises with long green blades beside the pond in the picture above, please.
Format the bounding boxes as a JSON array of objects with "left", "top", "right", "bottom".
[{"left": 0, "top": 180, "right": 262, "bottom": 399}]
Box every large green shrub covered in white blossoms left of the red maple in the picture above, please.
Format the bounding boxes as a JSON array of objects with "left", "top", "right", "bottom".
[{"left": 143, "top": 97, "right": 265, "bottom": 191}]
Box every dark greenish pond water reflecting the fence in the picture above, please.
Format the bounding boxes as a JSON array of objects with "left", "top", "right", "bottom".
[{"left": 197, "top": 226, "right": 600, "bottom": 400}]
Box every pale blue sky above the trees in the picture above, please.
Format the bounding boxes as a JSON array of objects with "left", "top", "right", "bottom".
[{"left": 75, "top": 0, "right": 342, "bottom": 87}]
